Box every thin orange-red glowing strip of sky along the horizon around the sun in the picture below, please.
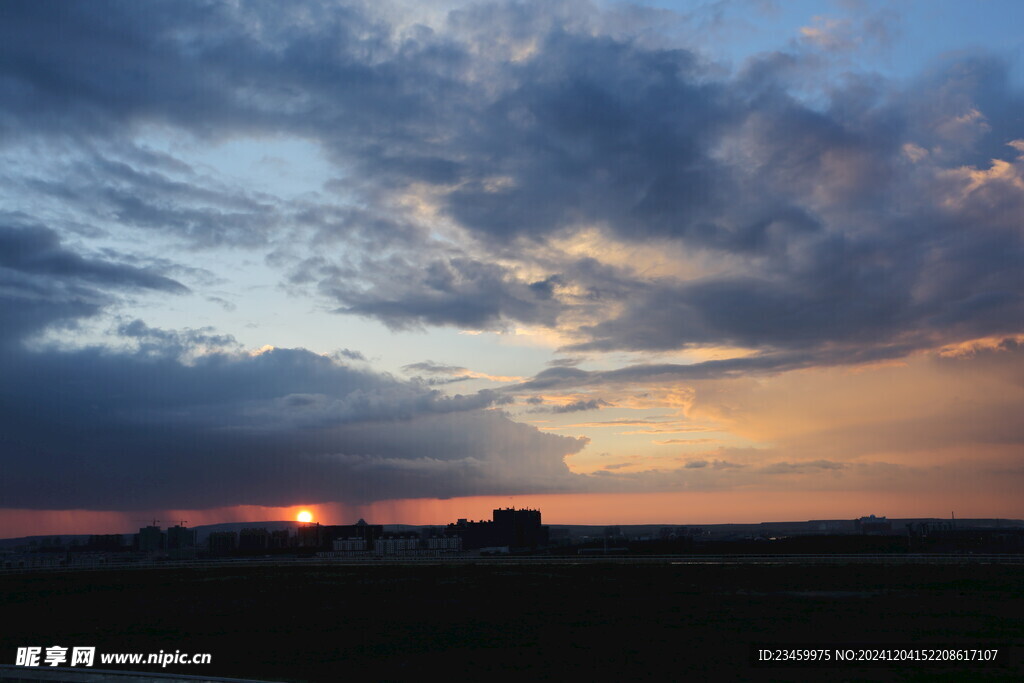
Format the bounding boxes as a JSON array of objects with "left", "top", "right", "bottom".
[{"left": 0, "top": 490, "right": 1024, "bottom": 538}]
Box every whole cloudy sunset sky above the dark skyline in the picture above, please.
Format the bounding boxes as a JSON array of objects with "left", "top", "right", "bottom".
[{"left": 0, "top": 0, "right": 1024, "bottom": 537}]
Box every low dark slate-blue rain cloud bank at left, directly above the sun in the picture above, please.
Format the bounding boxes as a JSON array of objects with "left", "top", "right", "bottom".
[{"left": 0, "top": 344, "right": 586, "bottom": 509}]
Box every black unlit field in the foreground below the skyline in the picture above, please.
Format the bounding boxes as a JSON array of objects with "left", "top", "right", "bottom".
[{"left": 0, "top": 565, "right": 1024, "bottom": 681}]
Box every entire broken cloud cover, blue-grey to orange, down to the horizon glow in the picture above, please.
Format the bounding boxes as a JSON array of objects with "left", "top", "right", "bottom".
[{"left": 0, "top": 0, "right": 1024, "bottom": 509}]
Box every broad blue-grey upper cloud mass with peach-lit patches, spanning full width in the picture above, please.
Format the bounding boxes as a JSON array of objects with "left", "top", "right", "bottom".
[{"left": 0, "top": 3, "right": 1024, "bottom": 359}]
